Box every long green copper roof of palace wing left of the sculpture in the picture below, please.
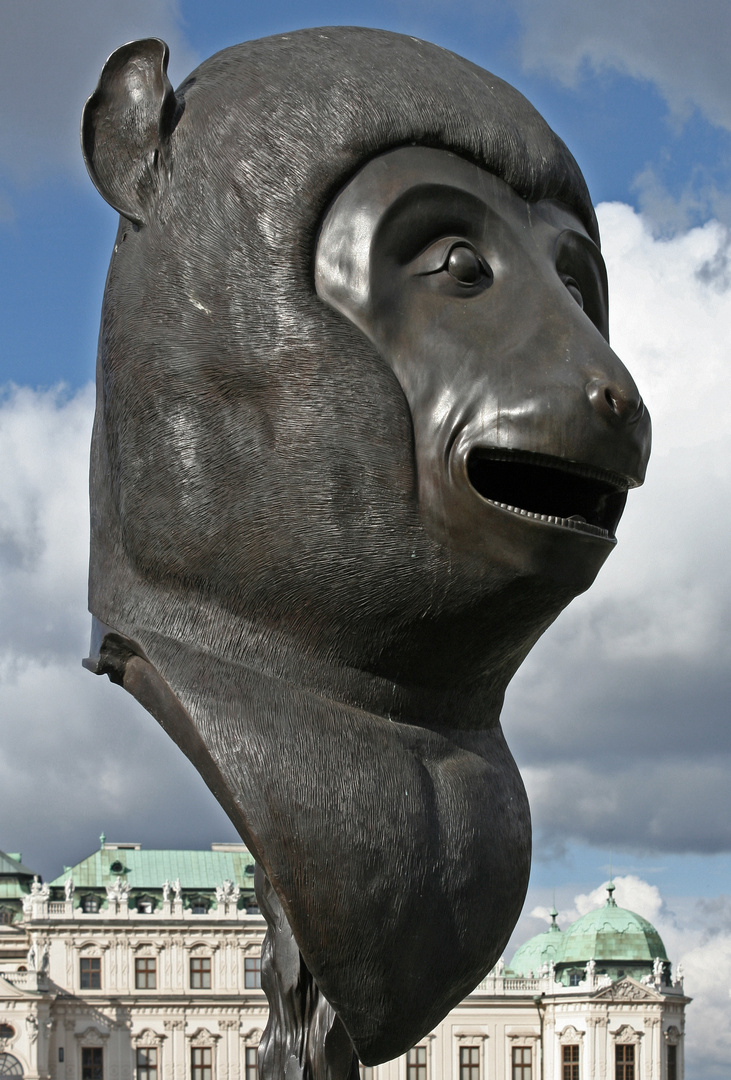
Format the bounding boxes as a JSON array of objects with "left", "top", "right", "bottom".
[{"left": 51, "top": 843, "right": 254, "bottom": 892}]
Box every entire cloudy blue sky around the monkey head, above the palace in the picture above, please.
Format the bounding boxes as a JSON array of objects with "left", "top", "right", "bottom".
[{"left": 0, "top": 0, "right": 731, "bottom": 1080}]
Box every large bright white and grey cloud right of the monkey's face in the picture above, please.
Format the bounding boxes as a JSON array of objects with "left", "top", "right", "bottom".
[{"left": 503, "top": 204, "right": 731, "bottom": 851}]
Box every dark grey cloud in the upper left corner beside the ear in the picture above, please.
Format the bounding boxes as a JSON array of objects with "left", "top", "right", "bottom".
[{"left": 0, "top": 0, "right": 194, "bottom": 187}]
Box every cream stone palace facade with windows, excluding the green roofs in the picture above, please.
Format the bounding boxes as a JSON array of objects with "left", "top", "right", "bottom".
[{"left": 0, "top": 868, "right": 688, "bottom": 1080}]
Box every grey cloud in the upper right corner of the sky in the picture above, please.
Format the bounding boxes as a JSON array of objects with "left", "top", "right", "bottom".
[{"left": 515, "top": 0, "right": 731, "bottom": 130}]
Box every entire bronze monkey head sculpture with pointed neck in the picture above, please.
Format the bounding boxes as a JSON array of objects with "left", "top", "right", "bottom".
[{"left": 82, "top": 28, "right": 650, "bottom": 1063}]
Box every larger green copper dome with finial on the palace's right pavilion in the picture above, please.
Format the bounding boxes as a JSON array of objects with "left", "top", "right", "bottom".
[{"left": 559, "top": 881, "right": 667, "bottom": 966}]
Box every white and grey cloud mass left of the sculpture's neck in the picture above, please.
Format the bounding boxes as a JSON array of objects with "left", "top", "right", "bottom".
[{"left": 0, "top": 387, "right": 233, "bottom": 877}]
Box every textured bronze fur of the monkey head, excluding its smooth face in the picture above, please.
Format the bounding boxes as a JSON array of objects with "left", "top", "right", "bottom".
[{"left": 84, "top": 28, "right": 608, "bottom": 1062}]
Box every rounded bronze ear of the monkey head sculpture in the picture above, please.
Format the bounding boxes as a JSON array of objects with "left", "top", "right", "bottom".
[{"left": 81, "top": 38, "right": 178, "bottom": 226}]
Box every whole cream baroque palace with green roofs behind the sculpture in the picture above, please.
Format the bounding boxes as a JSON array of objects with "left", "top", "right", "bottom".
[{"left": 0, "top": 837, "right": 689, "bottom": 1080}]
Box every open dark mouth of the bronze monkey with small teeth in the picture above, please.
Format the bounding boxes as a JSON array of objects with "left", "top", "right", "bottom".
[{"left": 468, "top": 447, "right": 630, "bottom": 540}]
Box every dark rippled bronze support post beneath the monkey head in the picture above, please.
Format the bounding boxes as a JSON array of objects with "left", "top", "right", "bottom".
[{"left": 255, "top": 865, "right": 360, "bottom": 1080}]
